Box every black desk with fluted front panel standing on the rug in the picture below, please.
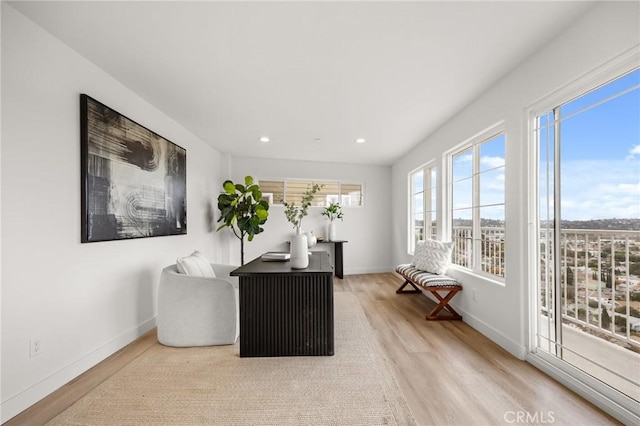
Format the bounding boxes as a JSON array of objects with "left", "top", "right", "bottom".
[{"left": 231, "top": 252, "right": 334, "bottom": 357}]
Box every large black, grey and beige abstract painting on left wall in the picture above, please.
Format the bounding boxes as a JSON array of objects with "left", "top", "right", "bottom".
[{"left": 80, "top": 94, "right": 187, "bottom": 243}]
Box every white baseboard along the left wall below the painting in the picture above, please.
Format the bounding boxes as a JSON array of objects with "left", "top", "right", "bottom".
[{"left": 0, "top": 317, "right": 156, "bottom": 423}]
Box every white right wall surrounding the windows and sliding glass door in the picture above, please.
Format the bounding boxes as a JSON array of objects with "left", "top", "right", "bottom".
[{"left": 392, "top": 2, "right": 640, "bottom": 358}]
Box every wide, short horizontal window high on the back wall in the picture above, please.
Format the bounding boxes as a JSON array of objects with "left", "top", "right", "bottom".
[{"left": 259, "top": 179, "right": 364, "bottom": 207}]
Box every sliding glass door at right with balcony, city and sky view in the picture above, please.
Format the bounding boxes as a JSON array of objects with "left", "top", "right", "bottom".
[{"left": 537, "top": 70, "right": 640, "bottom": 400}]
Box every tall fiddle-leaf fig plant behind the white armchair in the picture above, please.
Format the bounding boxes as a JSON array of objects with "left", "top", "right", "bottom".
[{"left": 216, "top": 176, "right": 269, "bottom": 265}]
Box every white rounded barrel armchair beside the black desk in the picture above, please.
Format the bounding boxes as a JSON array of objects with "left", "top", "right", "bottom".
[{"left": 157, "top": 264, "right": 240, "bottom": 347}]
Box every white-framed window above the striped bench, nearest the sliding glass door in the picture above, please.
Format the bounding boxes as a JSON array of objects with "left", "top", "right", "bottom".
[{"left": 449, "top": 131, "right": 505, "bottom": 278}]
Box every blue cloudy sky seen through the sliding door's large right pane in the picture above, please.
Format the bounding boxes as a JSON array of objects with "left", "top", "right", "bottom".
[{"left": 560, "top": 70, "right": 640, "bottom": 220}]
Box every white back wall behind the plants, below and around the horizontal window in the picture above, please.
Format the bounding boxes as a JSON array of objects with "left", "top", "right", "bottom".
[{"left": 228, "top": 157, "right": 392, "bottom": 275}]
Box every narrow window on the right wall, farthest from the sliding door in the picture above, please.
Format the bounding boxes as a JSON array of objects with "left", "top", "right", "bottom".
[{"left": 409, "top": 165, "right": 437, "bottom": 253}]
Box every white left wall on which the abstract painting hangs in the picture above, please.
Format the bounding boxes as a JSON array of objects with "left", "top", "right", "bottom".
[{"left": 1, "top": 2, "right": 227, "bottom": 421}]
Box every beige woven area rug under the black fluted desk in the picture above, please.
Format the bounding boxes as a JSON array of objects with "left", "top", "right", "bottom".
[{"left": 48, "top": 292, "right": 415, "bottom": 425}]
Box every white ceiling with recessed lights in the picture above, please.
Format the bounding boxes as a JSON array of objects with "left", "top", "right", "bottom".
[{"left": 10, "top": 1, "right": 593, "bottom": 165}]
